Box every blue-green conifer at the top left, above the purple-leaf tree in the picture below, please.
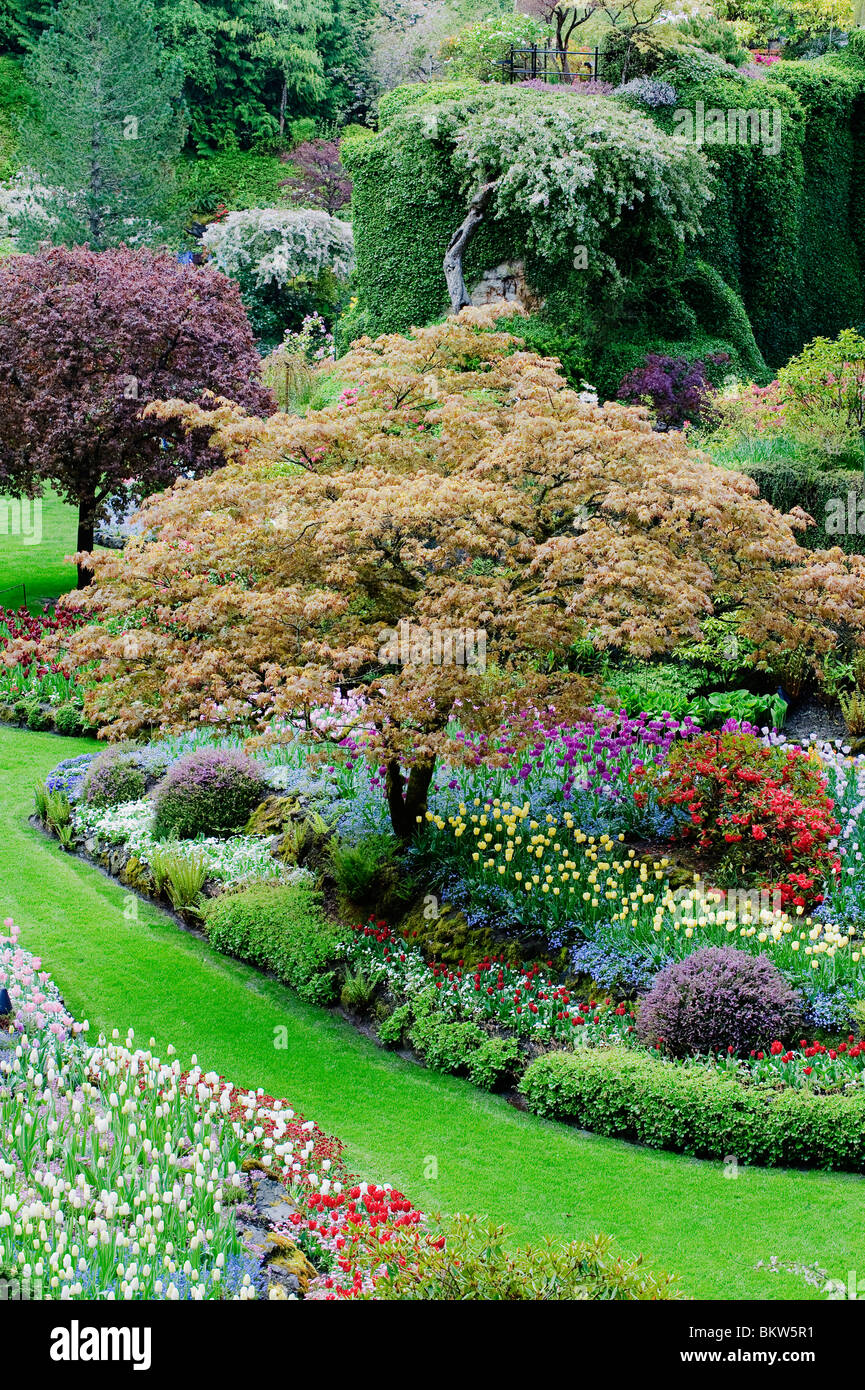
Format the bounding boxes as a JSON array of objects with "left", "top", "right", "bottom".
[{"left": 17, "top": 0, "right": 185, "bottom": 250}]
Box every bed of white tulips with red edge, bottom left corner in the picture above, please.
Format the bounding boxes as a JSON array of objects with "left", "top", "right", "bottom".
[{"left": 0, "top": 919, "right": 421, "bottom": 1300}]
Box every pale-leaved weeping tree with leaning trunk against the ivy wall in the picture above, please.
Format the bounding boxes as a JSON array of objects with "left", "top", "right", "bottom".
[{"left": 439, "top": 88, "right": 709, "bottom": 313}]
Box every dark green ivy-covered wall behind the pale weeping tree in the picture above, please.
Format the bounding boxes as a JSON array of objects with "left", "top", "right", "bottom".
[{"left": 339, "top": 44, "right": 865, "bottom": 380}]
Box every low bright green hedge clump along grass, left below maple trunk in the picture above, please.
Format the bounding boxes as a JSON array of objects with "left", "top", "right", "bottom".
[{"left": 204, "top": 883, "right": 343, "bottom": 1004}]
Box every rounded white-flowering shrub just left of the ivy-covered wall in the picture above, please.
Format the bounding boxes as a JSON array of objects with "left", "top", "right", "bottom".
[{"left": 202, "top": 207, "right": 355, "bottom": 288}]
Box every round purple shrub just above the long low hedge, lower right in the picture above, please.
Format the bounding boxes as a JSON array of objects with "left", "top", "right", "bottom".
[{"left": 637, "top": 947, "right": 802, "bottom": 1056}]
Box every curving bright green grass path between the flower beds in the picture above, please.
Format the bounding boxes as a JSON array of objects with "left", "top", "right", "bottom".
[{"left": 0, "top": 727, "right": 865, "bottom": 1298}]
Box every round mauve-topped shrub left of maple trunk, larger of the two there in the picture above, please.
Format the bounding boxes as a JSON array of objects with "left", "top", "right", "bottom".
[{"left": 153, "top": 748, "right": 271, "bottom": 840}]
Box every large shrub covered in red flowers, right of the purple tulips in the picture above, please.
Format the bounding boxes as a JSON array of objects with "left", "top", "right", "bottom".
[{"left": 631, "top": 731, "right": 841, "bottom": 909}]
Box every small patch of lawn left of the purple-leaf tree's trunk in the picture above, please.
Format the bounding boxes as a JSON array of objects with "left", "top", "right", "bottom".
[{"left": 0, "top": 492, "right": 78, "bottom": 607}]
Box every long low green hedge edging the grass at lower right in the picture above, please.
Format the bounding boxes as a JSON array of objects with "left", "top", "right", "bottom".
[{"left": 520, "top": 1048, "right": 865, "bottom": 1172}]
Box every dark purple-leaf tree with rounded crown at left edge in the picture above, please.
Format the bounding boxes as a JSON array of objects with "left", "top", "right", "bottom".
[{"left": 0, "top": 246, "right": 275, "bottom": 588}]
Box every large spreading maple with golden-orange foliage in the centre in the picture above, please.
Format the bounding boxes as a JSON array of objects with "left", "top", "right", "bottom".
[{"left": 54, "top": 310, "right": 865, "bottom": 834}]
